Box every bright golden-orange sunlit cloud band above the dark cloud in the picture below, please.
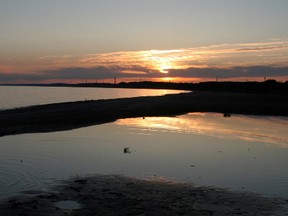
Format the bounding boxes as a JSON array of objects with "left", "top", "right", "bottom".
[{"left": 79, "top": 39, "right": 288, "bottom": 71}]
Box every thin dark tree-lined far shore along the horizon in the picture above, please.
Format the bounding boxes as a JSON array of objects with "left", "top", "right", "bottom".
[{"left": 0, "top": 79, "right": 288, "bottom": 95}]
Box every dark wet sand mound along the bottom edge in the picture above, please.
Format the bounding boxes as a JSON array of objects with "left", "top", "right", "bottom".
[{"left": 0, "top": 176, "right": 288, "bottom": 216}]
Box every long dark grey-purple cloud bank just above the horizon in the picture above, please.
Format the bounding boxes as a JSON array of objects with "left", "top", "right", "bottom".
[{"left": 0, "top": 66, "right": 288, "bottom": 83}]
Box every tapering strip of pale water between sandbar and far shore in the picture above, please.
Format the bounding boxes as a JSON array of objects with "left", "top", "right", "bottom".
[{"left": 0, "top": 86, "right": 183, "bottom": 110}]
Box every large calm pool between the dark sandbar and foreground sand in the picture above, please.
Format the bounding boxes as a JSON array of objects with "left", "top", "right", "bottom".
[{"left": 0, "top": 113, "right": 288, "bottom": 198}]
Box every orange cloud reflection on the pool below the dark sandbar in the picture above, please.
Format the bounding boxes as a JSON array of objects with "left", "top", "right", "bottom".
[{"left": 116, "top": 113, "right": 288, "bottom": 148}]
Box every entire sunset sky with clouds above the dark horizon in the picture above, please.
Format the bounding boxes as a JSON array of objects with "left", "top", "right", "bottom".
[{"left": 0, "top": 0, "right": 288, "bottom": 83}]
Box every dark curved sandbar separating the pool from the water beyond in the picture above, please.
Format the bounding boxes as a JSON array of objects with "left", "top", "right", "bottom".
[{"left": 0, "top": 91, "right": 288, "bottom": 136}]
